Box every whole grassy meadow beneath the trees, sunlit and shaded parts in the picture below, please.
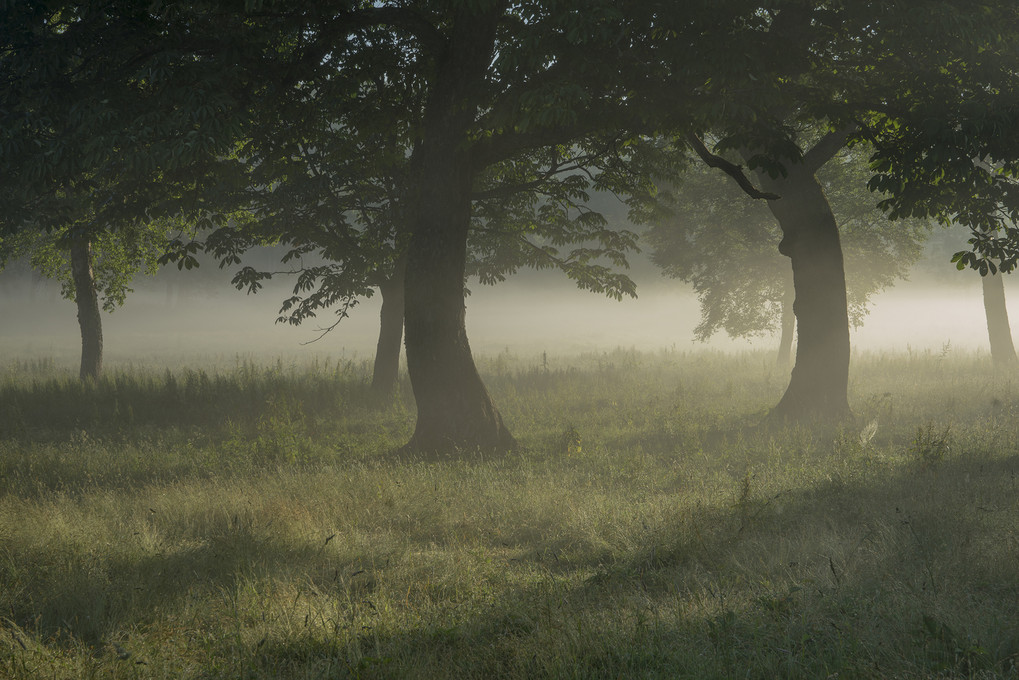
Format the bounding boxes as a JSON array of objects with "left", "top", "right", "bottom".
[{"left": 0, "top": 351, "right": 1019, "bottom": 679}]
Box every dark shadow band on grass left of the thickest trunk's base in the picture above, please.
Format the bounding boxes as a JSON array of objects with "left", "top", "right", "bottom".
[{"left": 0, "top": 367, "right": 409, "bottom": 498}]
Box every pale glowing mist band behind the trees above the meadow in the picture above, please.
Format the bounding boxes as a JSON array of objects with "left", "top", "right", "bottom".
[{"left": 0, "top": 239, "right": 1002, "bottom": 367}]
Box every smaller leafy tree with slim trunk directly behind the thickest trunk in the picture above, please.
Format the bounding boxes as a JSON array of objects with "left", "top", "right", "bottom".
[{"left": 164, "top": 53, "right": 635, "bottom": 404}]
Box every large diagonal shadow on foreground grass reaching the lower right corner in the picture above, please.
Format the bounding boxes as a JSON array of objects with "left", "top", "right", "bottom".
[{"left": 249, "top": 448, "right": 1019, "bottom": 678}]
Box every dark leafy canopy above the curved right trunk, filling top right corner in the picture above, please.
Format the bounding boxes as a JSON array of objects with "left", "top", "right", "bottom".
[{"left": 639, "top": 0, "right": 1019, "bottom": 279}]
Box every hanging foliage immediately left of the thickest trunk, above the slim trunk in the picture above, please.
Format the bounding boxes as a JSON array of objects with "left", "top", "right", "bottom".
[{"left": 183, "top": 11, "right": 422, "bottom": 324}]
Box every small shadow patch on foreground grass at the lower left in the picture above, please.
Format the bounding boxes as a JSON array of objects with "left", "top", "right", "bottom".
[{"left": 0, "top": 515, "right": 332, "bottom": 647}]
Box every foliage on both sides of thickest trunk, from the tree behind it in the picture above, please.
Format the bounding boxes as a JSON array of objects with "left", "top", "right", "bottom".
[{"left": 168, "top": 3, "right": 680, "bottom": 324}]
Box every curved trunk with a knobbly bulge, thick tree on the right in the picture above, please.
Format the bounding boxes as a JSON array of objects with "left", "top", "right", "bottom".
[{"left": 758, "top": 163, "right": 850, "bottom": 420}]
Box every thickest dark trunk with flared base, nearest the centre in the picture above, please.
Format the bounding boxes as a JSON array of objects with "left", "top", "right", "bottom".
[{"left": 395, "top": 8, "right": 516, "bottom": 452}]
